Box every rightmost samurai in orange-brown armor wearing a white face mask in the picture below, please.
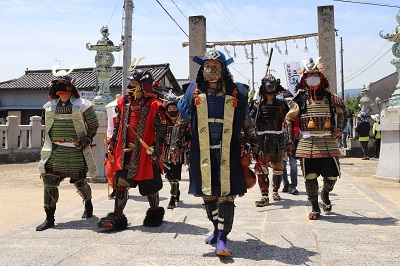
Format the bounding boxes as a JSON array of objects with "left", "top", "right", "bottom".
[{"left": 286, "top": 58, "right": 345, "bottom": 220}]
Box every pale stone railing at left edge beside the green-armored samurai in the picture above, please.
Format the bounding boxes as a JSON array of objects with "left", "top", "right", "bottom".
[{"left": 0, "top": 115, "right": 44, "bottom": 150}]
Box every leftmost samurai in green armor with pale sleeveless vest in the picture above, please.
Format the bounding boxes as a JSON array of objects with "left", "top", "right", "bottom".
[{"left": 36, "top": 70, "right": 99, "bottom": 231}]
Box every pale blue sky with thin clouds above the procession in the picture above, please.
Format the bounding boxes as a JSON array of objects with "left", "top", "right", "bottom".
[{"left": 0, "top": 0, "right": 400, "bottom": 92}]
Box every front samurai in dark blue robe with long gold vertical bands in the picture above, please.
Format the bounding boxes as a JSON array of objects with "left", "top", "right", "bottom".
[{"left": 178, "top": 50, "right": 258, "bottom": 256}]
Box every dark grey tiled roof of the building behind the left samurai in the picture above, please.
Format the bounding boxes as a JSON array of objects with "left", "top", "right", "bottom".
[{"left": 0, "top": 63, "right": 181, "bottom": 90}]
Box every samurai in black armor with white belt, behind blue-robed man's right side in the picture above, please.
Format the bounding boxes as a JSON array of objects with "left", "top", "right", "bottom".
[{"left": 255, "top": 75, "right": 289, "bottom": 207}]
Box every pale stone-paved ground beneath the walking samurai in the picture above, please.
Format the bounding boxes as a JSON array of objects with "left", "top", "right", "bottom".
[{"left": 0, "top": 159, "right": 400, "bottom": 265}]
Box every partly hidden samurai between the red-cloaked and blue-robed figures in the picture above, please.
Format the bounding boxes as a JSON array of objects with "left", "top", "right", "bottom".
[{"left": 163, "top": 90, "right": 190, "bottom": 209}]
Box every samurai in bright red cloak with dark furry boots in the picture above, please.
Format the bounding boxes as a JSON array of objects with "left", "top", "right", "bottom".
[{"left": 98, "top": 69, "right": 166, "bottom": 230}]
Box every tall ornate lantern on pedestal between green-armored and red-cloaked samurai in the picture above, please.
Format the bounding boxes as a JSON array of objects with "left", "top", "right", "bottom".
[{"left": 86, "top": 26, "right": 123, "bottom": 183}]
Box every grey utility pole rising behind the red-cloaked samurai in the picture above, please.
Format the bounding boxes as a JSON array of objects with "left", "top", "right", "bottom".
[{"left": 121, "top": 0, "right": 134, "bottom": 95}]
